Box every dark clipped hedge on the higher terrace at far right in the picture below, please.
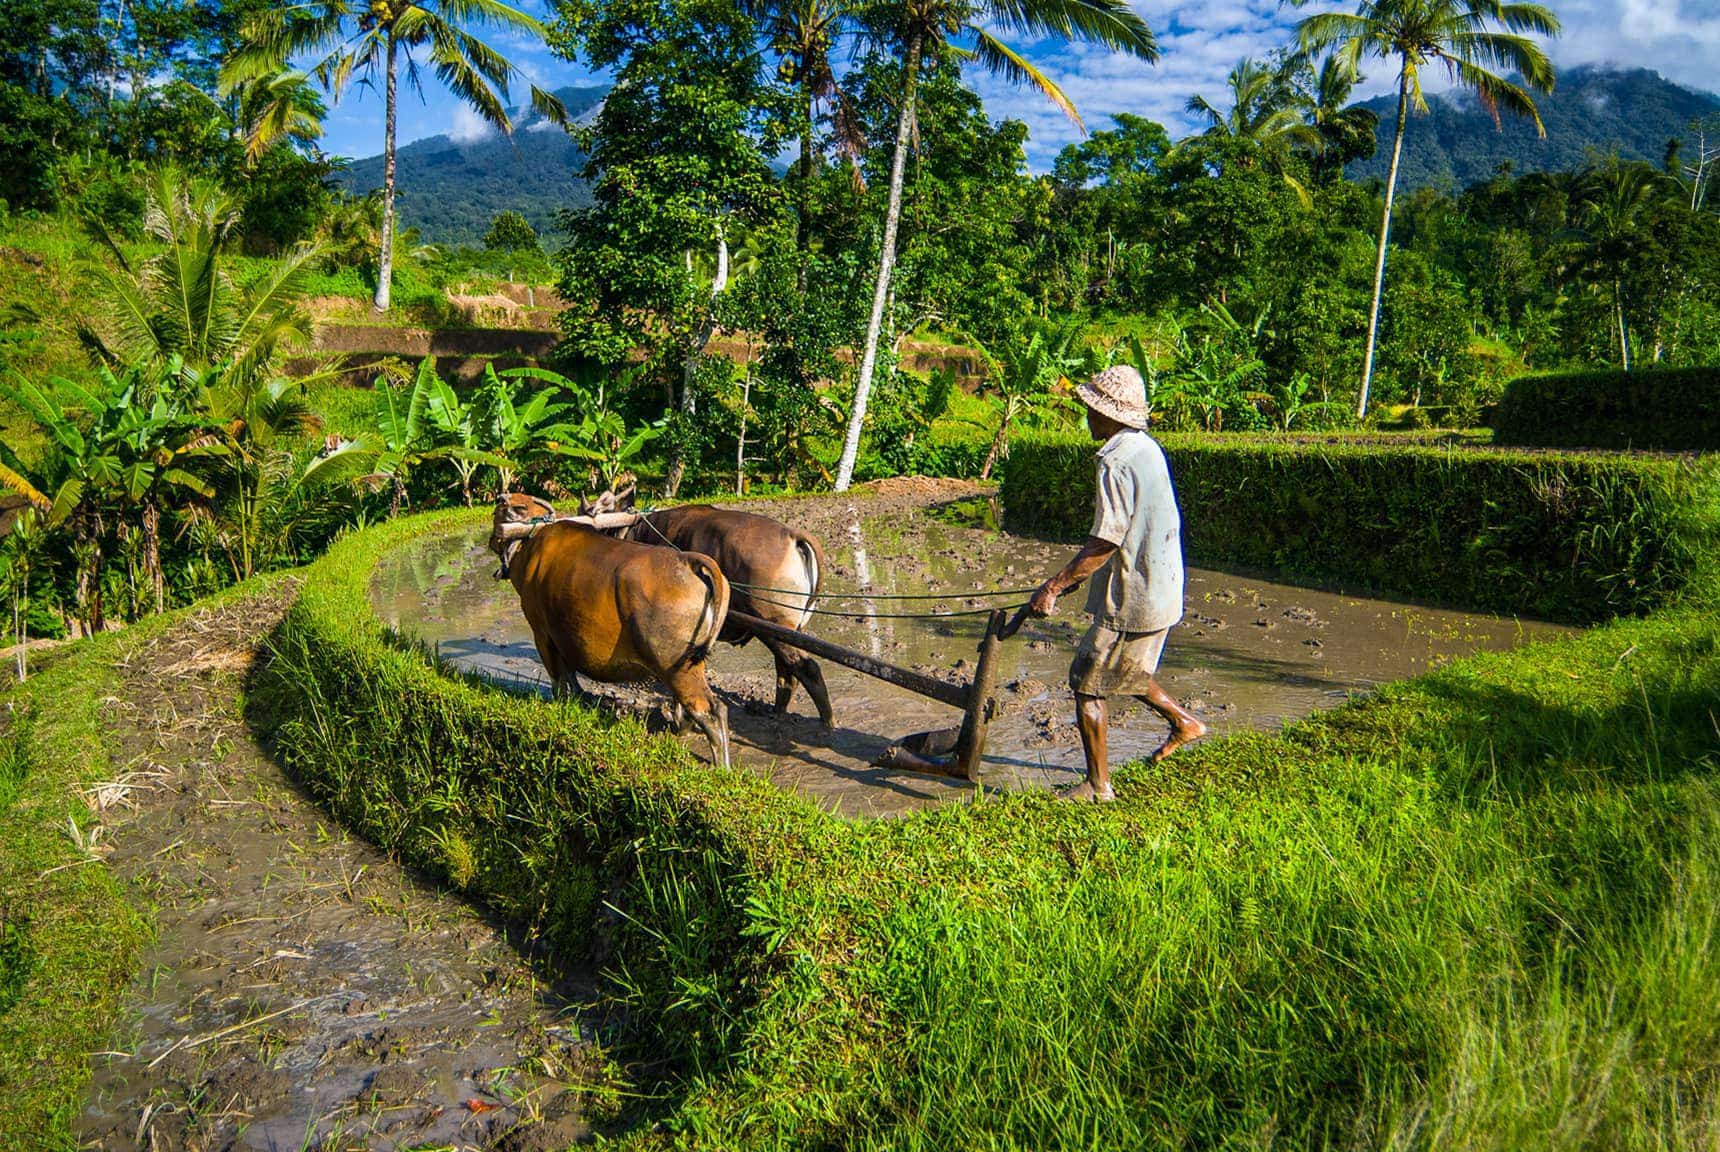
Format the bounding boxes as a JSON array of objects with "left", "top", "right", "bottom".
[{"left": 1493, "top": 366, "right": 1720, "bottom": 452}]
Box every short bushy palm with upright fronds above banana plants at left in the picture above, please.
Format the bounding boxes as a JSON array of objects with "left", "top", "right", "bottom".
[{"left": 83, "top": 167, "right": 320, "bottom": 387}]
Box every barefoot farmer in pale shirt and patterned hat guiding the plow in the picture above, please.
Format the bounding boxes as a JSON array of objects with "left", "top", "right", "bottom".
[{"left": 1027, "top": 365, "right": 1206, "bottom": 801}]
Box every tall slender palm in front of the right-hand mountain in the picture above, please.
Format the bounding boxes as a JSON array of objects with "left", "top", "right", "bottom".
[{"left": 1297, "top": 0, "right": 1558, "bottom": 420}]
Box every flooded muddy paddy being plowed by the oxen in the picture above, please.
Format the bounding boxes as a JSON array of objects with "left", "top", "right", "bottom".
[{"left": 372, "top": 499, "right": 1562, "bottom": 815}]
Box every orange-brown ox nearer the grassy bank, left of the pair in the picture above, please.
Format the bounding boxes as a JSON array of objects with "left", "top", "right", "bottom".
[{"left": 490, "top": 493, "right": 729, "bottom": 767}]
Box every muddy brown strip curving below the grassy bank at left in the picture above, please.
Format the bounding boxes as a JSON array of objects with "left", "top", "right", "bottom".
[{"left": 77, "top": 590, "right": 599, "bottom": 1152}]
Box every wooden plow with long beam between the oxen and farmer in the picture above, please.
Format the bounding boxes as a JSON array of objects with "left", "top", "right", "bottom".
[{"left": 729, "top": 607, "right": 1027, "bottom": 781}]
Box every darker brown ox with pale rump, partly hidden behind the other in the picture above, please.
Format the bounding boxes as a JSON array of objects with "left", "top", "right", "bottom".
[{"left": 583, "top": 488, "right": 834, "bottom": 726}]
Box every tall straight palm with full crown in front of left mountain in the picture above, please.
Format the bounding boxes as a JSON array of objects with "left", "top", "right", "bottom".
[{"left": 222, "top": 0, "right": 568, "bottom": 313}]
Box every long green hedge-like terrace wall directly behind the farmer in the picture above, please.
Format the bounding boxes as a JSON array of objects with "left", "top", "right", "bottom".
[{"left": 1003, "top": 435, "right": 1720, "bottom": 622}]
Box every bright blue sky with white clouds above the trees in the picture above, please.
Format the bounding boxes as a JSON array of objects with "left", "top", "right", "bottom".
[{"left": 323, "top": 0, "right": 1720, "bottom": 170}]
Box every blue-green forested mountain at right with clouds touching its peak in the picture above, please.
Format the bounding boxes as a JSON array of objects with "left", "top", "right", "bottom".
[{"left": 1345, "top": 65, "right": 1720, "bottom": 191}]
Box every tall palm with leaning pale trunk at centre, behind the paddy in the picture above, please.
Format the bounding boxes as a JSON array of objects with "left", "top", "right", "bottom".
[{"left": 836, "top": 0, "right": 1159, "bottom": 492}]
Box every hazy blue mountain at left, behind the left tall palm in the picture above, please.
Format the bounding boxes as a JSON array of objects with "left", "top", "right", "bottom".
[{"left": 337, "top": 86, "right": 609, "bottom": 244}]
